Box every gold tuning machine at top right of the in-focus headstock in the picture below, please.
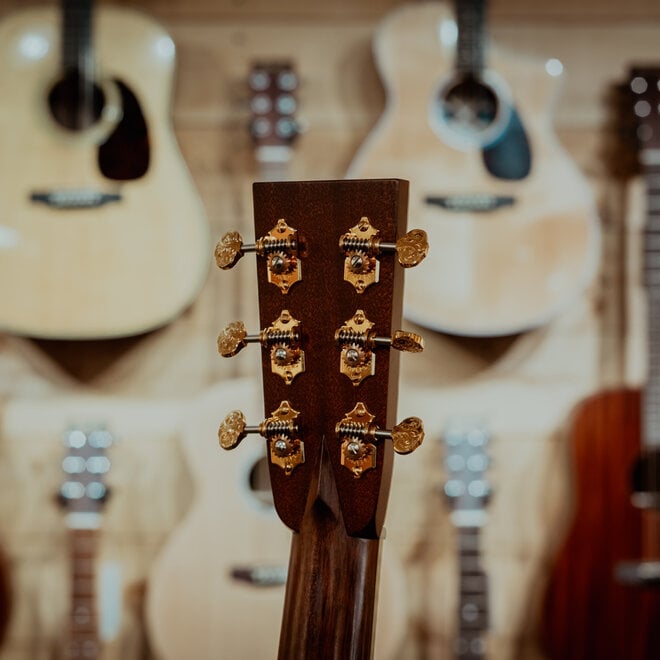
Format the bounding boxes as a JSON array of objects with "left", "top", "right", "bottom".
[{"left": 339, "top": 216, "right": 429, "bottom": 293}]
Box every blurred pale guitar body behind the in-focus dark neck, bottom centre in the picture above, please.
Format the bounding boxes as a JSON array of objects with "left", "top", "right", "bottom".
[{"left": 146, "top": 380, "right": 407, "bottom": 660}]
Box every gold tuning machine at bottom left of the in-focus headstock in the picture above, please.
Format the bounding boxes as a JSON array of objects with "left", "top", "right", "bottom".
[{"left": 218, "top": 401, "right": 305, "bottom": 476}]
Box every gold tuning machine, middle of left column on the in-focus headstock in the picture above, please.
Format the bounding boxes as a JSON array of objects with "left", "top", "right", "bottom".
[{"left": 218, "top": 309, "right": 305, "bottom": 385}]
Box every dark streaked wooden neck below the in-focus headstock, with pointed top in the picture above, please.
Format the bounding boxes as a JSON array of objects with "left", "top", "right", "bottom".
[{"left": 278, "top": 451, "right": 380, "bottom": 660}]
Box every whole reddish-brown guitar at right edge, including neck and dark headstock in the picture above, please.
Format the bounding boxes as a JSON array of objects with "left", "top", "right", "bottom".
[{"left": 542, "top": 69, "right": 660, "bottom": 660}]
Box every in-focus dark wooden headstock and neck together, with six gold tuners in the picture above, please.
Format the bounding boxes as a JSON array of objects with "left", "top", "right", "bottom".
[{"left": 216, "top": 180, "right": 428, "bottom": 659}]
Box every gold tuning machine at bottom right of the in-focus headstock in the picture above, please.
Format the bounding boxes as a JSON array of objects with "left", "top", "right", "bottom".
[{"left": 335, "top": 402, "right": 424, "bottom": 479}]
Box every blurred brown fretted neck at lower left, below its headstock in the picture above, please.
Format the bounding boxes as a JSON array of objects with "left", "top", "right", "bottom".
[{"left": 68, "top": 529, "right": 100, "bottom": 658}]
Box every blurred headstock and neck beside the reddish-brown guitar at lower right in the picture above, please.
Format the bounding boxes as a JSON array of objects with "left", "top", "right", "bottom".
[{"left": 443, "top": 421, "right": 490, "bottom": 660}]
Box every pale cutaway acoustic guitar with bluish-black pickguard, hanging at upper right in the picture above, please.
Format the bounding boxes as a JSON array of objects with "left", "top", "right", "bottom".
[{"left": 348, "top": 0, "right": 599, "bottom": 336}]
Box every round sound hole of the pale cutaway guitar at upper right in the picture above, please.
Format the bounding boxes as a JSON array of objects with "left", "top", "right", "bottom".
[{"left": 437, "top": 76, "right": 500, "bottom": 146}]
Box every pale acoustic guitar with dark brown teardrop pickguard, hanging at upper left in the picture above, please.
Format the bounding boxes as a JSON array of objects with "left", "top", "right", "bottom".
[{"left": 0, "top": 0, "right": 208, "bottom": 339}]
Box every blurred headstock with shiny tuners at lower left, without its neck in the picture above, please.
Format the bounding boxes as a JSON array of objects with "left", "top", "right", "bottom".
[{"left": 59, "top": 428, "right": 113, "bottom": 527}]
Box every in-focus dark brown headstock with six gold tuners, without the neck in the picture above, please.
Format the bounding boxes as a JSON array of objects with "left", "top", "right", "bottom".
[{"left": 216, "top": 179, "right": 428, "bottom": 538}]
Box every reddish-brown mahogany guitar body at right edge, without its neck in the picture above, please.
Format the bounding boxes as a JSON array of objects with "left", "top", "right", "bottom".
[{"left": 542, "top": 390, "right": 660, "bottom": 660}]
